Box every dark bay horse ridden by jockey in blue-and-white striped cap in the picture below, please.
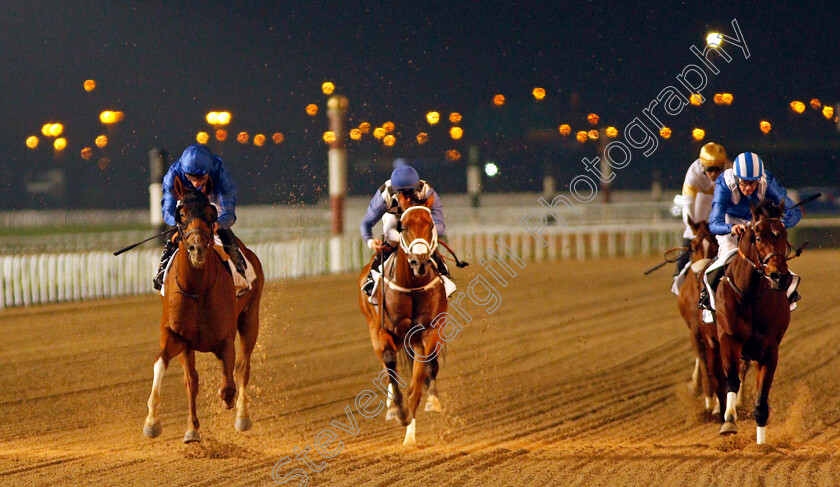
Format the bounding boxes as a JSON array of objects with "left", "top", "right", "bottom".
[{"left": 715, "top": 199, "right": 792, "bottom": 445}]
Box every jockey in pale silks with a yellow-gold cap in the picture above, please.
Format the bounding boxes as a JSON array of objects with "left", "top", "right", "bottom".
[{"left": 674, "top": 142, "right": 732, "bottom": 278}]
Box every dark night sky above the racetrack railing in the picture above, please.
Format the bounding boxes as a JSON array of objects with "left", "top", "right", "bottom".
[{"left": 0, "top": 1, "right": 840, "bottom": 208}]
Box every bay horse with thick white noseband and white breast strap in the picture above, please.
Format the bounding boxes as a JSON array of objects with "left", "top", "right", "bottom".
[{"left": 359, "top": 193, "right": 448, "bottom": 446}]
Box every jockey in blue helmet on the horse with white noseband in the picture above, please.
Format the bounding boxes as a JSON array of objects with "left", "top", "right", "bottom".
[{"left": 360, "top": 165, "right": 455, "bottom": 296}]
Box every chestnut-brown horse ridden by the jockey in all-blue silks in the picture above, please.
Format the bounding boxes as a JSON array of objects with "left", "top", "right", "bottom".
[{"left": 143, "top": 178, "right": 265, "bottom": 443}]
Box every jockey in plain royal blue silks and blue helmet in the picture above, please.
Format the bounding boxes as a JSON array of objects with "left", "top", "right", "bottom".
[{"left": 154, "top": 144, "right": 245, "bottom": 289}]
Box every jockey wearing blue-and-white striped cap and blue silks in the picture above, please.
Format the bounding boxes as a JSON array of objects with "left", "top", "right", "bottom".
[{"left": 698, "top": 152, "right": 802, "bottom": 314}]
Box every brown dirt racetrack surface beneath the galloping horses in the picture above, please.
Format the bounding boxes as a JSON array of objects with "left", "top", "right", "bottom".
[{"left": 0, "top": 251, "right": 840, "bottom": 487}]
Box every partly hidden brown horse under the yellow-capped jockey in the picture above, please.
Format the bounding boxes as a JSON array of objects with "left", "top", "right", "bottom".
[{"left": 677, "top": 217, "right": 724, "bottom": 411}]
